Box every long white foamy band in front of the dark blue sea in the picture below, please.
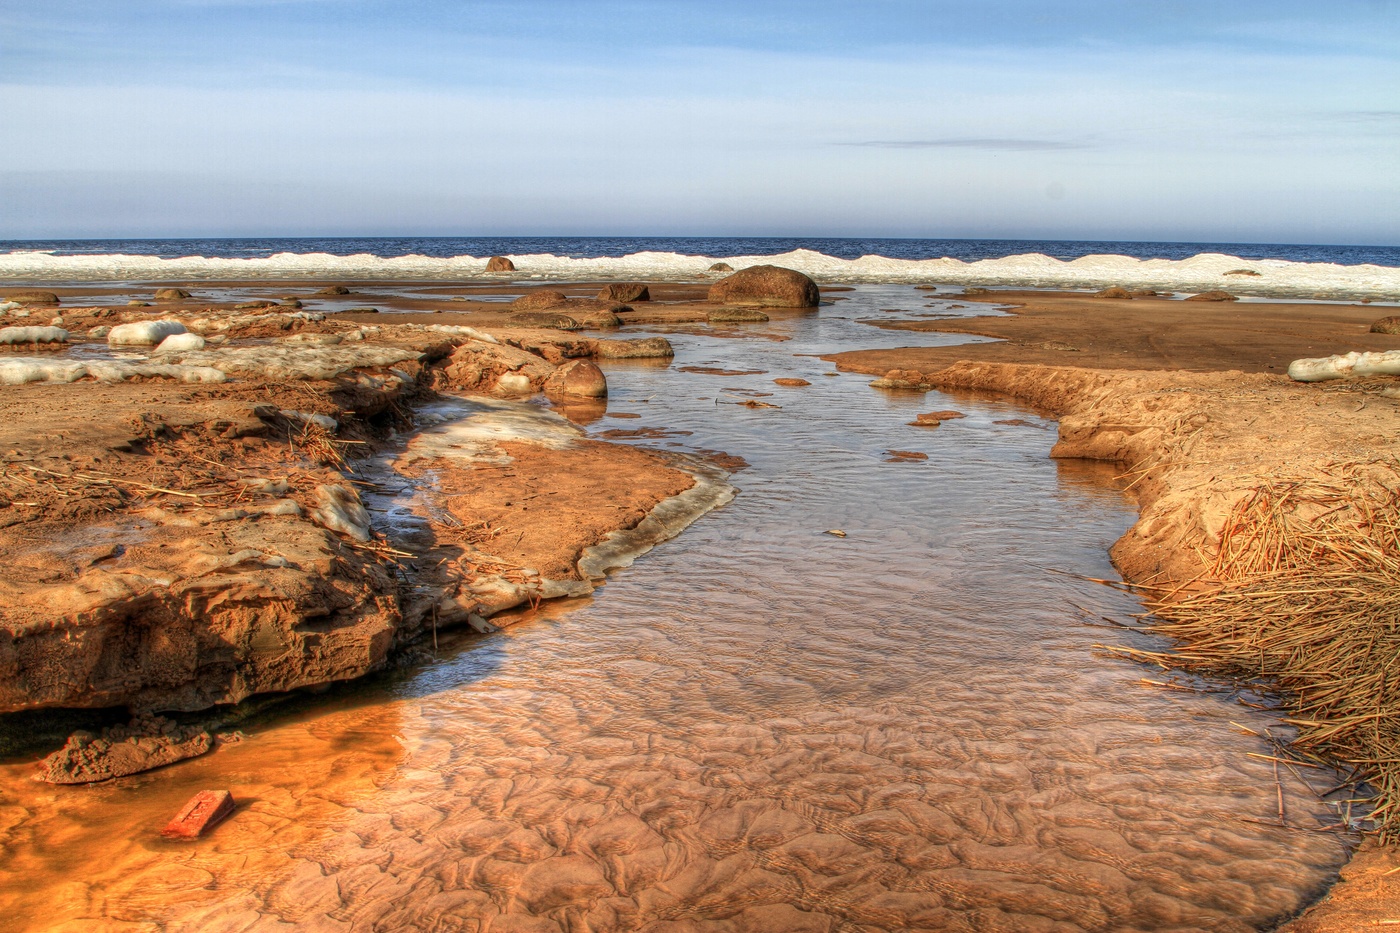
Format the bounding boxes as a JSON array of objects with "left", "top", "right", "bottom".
[{"left": 0, "top": 243, "right": 1400, "bottom": 300}]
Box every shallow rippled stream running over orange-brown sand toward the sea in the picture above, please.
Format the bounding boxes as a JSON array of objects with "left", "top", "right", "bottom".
[{"left": 0, "top": 287, "right": 1345, "bottom": 933}]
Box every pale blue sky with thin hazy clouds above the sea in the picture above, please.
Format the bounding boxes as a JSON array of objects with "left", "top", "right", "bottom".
[{"left": 0, "top": 0, "right": 1400, "bottom": 245}]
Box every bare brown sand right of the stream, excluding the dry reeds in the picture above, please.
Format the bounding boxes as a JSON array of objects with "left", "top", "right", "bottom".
[{"left": 826, "top": 291, "right": 1400, "bottom": 933}]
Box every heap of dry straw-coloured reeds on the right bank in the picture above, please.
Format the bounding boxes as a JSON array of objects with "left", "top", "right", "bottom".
[{"left": 1149, "top": 462, "right": 1400, "bottom": 842}]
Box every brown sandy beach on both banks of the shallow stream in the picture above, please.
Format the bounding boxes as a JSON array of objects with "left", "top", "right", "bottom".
[{"left": 0, "top": 273, "right": 1400, "bottom": 933}]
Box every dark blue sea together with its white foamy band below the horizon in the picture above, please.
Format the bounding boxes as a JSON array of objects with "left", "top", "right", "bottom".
[{"left": 0, "top": 237, "right": 1400, "bottom": 301}]
